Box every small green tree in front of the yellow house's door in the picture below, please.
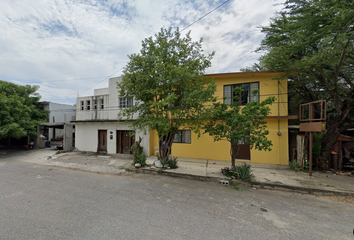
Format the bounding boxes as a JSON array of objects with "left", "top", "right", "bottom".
[{"left": 204, "top": 88, "right": 275, "bottom": 168}]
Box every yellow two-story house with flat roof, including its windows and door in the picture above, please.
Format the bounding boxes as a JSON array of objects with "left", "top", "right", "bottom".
[{"left": 150, "top": 72, "right": 296, "bottom": 165}]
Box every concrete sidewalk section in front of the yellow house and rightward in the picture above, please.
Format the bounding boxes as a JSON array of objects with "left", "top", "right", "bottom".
[{"left": 142, "top": 157, "right": 354, "bottom": 196}]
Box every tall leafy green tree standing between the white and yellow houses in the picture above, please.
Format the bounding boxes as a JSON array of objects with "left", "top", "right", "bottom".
[{"left": 118, "top": 28, "right": 216, "bottom": 158}]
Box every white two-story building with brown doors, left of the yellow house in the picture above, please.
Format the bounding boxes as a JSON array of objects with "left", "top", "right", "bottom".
[{"left": 73, "top": 77, "right": 150, "bottom": 156}]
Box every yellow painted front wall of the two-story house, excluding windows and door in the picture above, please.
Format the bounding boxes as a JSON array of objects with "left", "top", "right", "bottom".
[{"left": 150, "top": 73, "right": 289, "bottom": 165}]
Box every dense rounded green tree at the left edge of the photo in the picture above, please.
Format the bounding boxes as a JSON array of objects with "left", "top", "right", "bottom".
[{"left": 0, "top": 81, "right": 47, "bottom": 144}]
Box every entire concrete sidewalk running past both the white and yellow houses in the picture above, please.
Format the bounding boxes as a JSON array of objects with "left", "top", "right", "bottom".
[{"left": 15, "top": 150, "right": 354, "bottom": 196}]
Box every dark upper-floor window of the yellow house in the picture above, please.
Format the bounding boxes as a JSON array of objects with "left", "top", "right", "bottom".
[{"left": 224, "top": 82, "right": 259, "bottom": 105}]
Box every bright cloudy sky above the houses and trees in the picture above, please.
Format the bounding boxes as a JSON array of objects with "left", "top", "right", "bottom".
[{"left": 0, "top": 0, "right": 284, "bottom": 105}]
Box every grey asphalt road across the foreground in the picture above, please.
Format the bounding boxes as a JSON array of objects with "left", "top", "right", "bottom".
[{"left": 0, "top": 151, "right": 354, "bottom": 240}]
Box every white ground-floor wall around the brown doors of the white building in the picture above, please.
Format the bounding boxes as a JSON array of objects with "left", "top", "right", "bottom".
[{"left": 75, "top": 122, "right": 150, "bottom": 156}]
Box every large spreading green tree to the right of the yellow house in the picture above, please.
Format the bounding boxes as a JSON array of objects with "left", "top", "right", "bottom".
[{"left": 252, "top": 0, "right": 354, "bottom": 169}]
